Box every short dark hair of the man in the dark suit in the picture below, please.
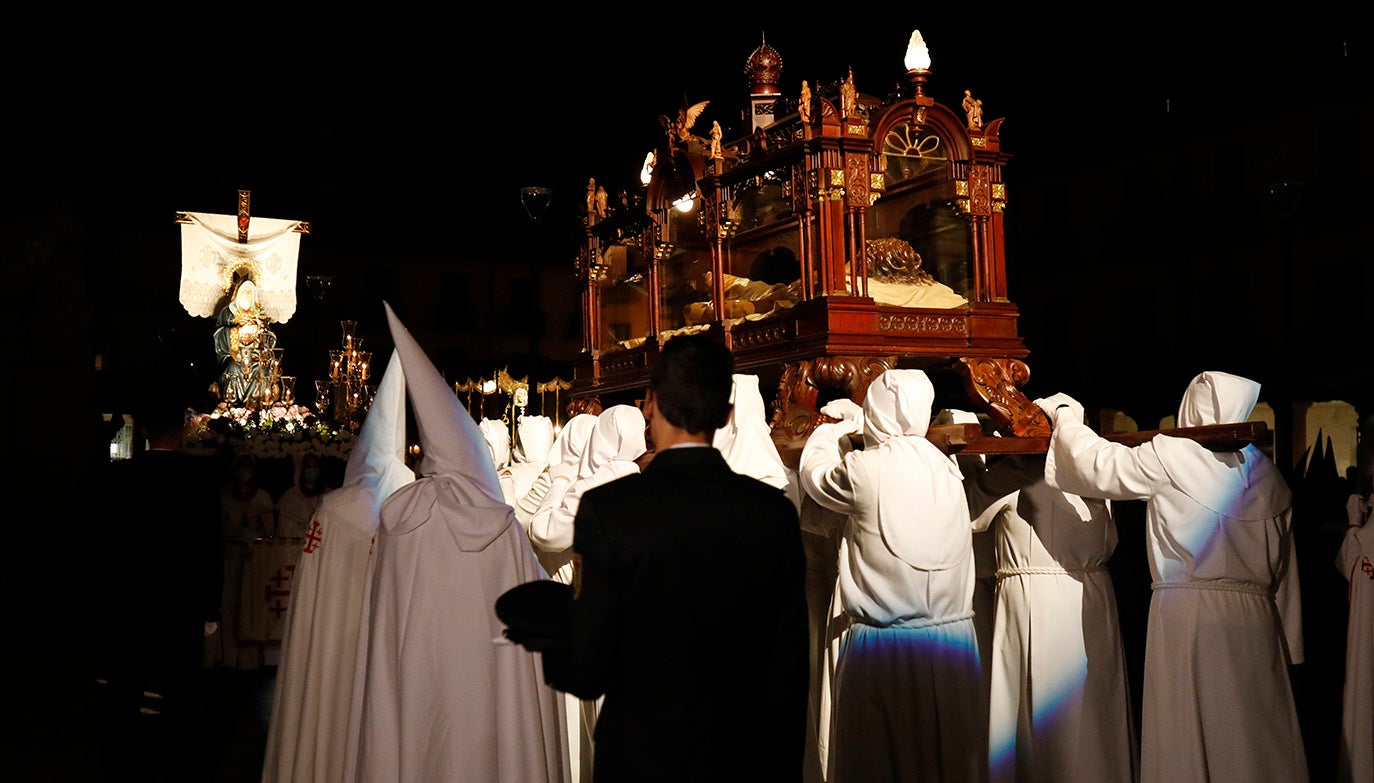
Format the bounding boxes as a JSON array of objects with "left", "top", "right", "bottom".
[{"left": 649, "top": 334, "right": 735, "bottom": 434}]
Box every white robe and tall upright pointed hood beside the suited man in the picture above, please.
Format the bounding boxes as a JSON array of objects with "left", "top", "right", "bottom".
[{"left": 357, "top": 305, "right": 567, "bottom": 783}]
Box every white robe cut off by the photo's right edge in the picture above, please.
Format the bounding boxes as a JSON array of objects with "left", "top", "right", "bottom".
[{"left": 1336, "top": 496, "right": 1374, "bottom": 783}]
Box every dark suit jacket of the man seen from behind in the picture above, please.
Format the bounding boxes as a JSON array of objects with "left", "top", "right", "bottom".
[{"left": 544, "top": 446, "right": 808, "bottom": 783}]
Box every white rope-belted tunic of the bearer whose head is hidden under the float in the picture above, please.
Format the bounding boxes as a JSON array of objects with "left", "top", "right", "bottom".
[{"left": 966, "top": 456, "right": 1139, "bottom": 783}]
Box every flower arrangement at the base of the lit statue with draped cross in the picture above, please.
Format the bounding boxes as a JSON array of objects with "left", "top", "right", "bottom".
[{"left": 183, "top": 402, "right": 356, "bottom": 460}]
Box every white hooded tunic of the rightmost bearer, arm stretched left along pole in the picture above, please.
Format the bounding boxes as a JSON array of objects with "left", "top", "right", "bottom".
[{"left": 1046, "top": 374, "right": 1308, "bottom": 783}]
